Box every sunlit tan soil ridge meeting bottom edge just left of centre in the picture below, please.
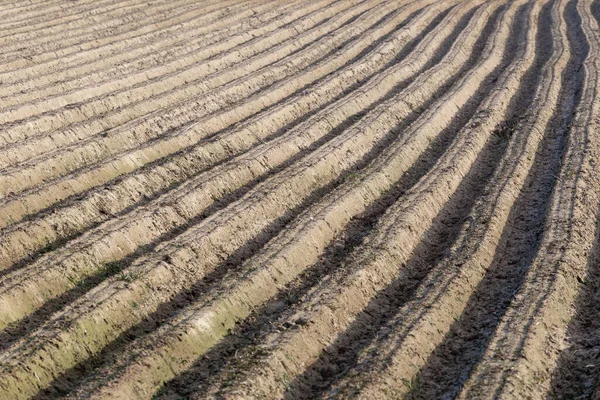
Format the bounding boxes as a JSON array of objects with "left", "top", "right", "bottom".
[{"left": 199, "top": 2, "right": 533, "bottom": 398}]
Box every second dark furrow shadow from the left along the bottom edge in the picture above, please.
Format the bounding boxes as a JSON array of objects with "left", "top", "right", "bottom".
[{"left": 151, "top": 4, "right": 510, "bottom": 398}]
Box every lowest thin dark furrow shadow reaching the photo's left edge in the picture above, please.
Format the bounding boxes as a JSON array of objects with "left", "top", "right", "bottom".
[{"left": 0, "top": 3, "right": 454, "bottom": 350}]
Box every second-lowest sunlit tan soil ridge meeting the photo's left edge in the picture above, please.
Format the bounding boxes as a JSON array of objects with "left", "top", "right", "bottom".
[{"left": 0, "top": 0, "right": 476, "bottom": 334}]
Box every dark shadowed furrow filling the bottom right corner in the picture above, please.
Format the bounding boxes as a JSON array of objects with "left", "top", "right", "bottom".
[{"left": 551, "top": 0, "right": 600, "bottom": 399}]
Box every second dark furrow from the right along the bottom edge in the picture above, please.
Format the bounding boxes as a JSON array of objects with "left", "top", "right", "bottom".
[{"left": 404, "top": 1, "right": 568, "bottom": 398}]
